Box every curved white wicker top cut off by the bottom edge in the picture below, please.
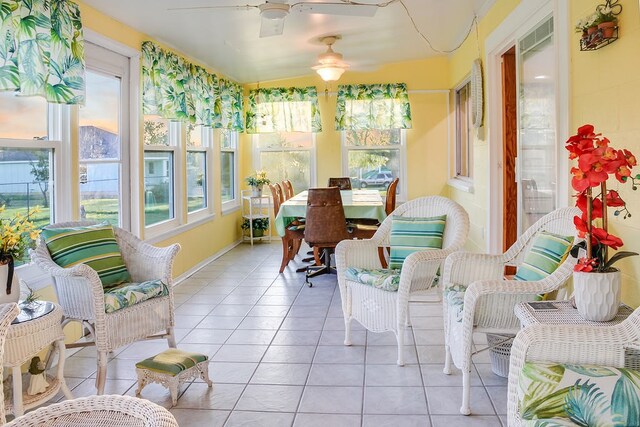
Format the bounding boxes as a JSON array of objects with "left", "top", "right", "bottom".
[{"left": 6, "top": 395, "right": 178, "bottom": 427}]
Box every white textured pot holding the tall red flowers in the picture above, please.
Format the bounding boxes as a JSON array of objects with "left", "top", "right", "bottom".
[{"left": 573, "top": 270, "right": 620, "bottom": 322}]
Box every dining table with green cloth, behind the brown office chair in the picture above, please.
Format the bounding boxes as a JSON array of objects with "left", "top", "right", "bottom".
[{"left": 274, "top": 190, "right": 387, "bottom": 236}]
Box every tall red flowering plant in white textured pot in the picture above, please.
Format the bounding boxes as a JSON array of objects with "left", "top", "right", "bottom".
[{"left": 566, "top": 125, "right": 640, "bottom": 321}]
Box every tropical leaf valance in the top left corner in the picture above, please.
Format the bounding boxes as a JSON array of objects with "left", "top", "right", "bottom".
[{"left": 0, "top": 0, "right": 85, "bottom": 104}]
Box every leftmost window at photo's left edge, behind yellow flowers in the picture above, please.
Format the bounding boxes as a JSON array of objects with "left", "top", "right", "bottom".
[{"left": 0, "top": 92, "right": 59, "bottom": 237}]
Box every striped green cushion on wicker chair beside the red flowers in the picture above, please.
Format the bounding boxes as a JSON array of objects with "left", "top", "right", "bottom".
[{"left": 515, "top": 231, "right": 573, "bottom": 282}]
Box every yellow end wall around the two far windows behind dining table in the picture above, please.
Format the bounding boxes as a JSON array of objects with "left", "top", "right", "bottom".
[{"left": 242, "top": 57, "right": 449, "bottom": 199}]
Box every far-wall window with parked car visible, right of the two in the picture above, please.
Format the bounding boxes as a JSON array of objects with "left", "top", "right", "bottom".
[{"left": 342, "top": 129, "right": 406, "bottom": 200}]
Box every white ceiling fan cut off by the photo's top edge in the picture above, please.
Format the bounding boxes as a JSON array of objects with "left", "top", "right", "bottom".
[{"left": 168, "top": 0, "right": 398, "bottom": 37}]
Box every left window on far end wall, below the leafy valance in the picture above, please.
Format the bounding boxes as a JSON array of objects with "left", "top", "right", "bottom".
[{"left": 253, "top": 132, "right": 315, "bottom": 192}]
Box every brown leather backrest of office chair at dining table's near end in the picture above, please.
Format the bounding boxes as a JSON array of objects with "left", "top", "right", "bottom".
[{"left": 304, "top": 187, "right": 349, "bottom": 247}]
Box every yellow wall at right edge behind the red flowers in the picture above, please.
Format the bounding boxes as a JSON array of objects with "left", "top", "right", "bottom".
[{"left": 570, "top": 0, "right": 640, "bottom": 307}]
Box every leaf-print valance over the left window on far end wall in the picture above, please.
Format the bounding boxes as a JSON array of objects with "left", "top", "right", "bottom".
[{"left": 246, "top": 86, "right": 322, "bottom": 133}]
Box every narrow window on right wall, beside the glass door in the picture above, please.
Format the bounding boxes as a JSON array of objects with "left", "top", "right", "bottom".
[{"left": 455, "top": 82, "right": 471, "bottom": 178}]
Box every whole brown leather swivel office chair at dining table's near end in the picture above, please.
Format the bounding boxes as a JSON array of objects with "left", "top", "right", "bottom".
[{"left": 304, "top": 187, "right": 351, "bottom": 286}]
